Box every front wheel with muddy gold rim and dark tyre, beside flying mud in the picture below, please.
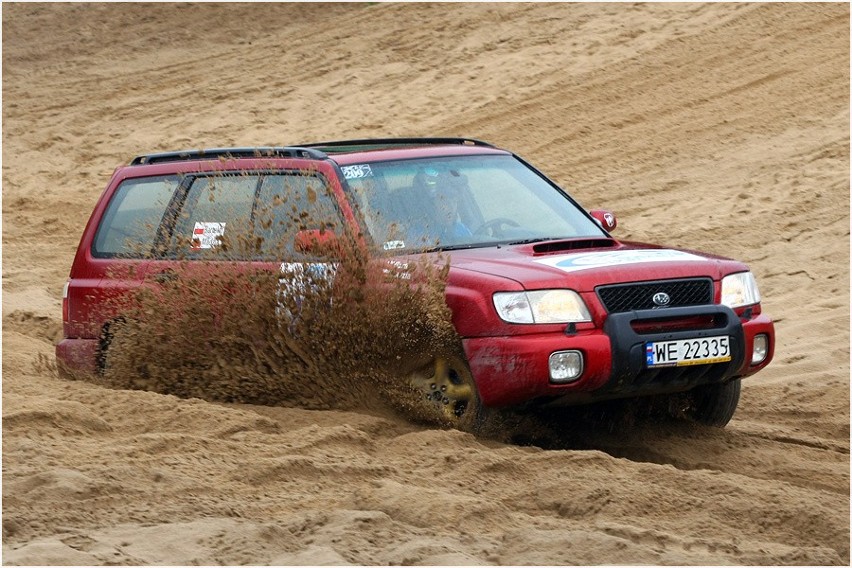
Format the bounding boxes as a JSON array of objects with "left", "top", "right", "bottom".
[{"left": 407, "top": 355, "right": 484, "bottom": 432}]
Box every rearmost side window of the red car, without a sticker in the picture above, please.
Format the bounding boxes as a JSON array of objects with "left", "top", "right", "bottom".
[{"left": 92, "top": 176, "right": 180, "bottom": 258}]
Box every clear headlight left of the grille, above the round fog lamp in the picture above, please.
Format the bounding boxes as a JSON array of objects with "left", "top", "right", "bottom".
[{"left": 494, "top": 290, "right": 592, "bottom": 323}]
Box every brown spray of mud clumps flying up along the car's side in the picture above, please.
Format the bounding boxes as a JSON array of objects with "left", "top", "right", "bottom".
[{"left": 99, "top": 224, "right": 461, "bottom": 420}]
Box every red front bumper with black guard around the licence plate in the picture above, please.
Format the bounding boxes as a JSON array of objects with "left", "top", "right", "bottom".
[{"left": 464, "top": 305, "right": 775, "bottom": 406}]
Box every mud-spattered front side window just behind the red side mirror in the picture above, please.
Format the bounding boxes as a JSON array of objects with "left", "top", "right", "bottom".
[{"left": 255, "top": 172, "right": 343, "bottom": 258}]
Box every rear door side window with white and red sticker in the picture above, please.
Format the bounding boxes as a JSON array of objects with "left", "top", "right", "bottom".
[{"left": 172, "top": 175, "right": 260, "bottom": 258}]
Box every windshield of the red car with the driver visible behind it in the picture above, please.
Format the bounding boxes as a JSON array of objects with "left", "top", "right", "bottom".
[{"left": 343, "top": 155, "right": 606, "bottom": 252}]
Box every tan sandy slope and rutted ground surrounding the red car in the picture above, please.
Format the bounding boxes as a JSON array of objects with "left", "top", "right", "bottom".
[{"left": 2, "top": 3, "right": 850, "bottom": 565}]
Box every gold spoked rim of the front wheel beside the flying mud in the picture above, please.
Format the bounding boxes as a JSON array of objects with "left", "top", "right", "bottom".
[{"left": 409, "top": 357, "right": 476, "bottom": 426}]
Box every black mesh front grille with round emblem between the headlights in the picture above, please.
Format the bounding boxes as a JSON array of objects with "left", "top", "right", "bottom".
[{"left": 596, "top": 278, "right": 713, "bottom": 314}]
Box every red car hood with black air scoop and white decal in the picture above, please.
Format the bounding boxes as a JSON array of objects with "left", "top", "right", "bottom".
[{"left": 446, "top": 241, "right": 748, "bottom": 292}]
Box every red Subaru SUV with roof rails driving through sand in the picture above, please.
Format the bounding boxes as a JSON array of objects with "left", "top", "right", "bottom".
[{"left": 56, "top": 138, "right": 775, "bottom": 427}]
